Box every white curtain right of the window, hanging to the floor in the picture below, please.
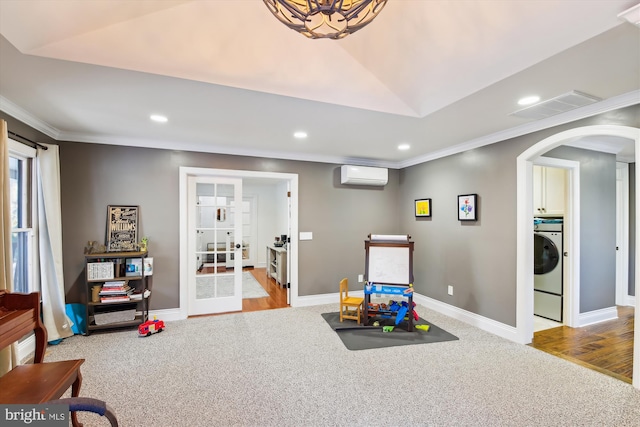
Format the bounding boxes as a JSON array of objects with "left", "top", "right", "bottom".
[{"left": 36, "top": 144, "right": 73, "bottom": 341}]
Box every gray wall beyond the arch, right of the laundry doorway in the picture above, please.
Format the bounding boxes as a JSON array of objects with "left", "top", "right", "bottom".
[{"left": 545, "top": 147, "right": 616, "bottom": 313}]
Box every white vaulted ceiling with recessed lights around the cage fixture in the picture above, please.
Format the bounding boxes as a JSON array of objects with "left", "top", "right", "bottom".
[{"left": 0, "top": 0, "right": 640, "bottom": 167}]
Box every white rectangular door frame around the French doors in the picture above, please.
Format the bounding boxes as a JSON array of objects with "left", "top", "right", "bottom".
[{"left": 178, "top": 166, "right": 298, "bottom": 318}]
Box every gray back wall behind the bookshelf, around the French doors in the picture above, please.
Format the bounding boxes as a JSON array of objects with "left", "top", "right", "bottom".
[{"left": 53, "top": 142, "right": 399, "bottom": 309}]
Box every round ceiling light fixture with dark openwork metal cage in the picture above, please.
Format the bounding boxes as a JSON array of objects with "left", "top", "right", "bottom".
[{"left": 263, "top": 0, "right": 387, "bottom": 39}]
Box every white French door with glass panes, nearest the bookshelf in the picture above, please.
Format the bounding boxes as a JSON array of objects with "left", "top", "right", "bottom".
[{"left": 187, "top": 176, "right": 243, "bottom": 315}]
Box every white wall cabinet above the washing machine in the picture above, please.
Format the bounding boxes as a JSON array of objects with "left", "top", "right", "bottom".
[{"left": 533, "top": 165, "right": 566, "bottom": 216}]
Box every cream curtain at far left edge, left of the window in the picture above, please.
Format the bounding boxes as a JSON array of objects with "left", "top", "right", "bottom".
[{"left": 0, "top": 120, "right": 16, "bottom": 376}]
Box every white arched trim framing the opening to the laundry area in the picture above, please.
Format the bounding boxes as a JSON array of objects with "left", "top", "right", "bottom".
[{"left": 516, "top": 125, "right": 640, "bottom": 389}]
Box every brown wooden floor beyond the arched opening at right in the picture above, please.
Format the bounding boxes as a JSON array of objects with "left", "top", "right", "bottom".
[{"left": 530, "top": 307, "right": 634, "bottom": 383}]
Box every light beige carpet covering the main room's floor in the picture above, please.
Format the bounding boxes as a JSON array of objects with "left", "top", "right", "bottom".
[{"left": 45, "top": 302, "right": 640, "bottom": 427}]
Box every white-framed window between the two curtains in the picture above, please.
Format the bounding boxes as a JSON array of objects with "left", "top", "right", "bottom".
[{"left": 9, "top": 140, "right": 40, "bottom": 292}]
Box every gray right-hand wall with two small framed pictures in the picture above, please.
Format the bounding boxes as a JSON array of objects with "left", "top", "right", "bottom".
[{"left": 399, "top": 106, "right": 640, "bottom": 326}]
